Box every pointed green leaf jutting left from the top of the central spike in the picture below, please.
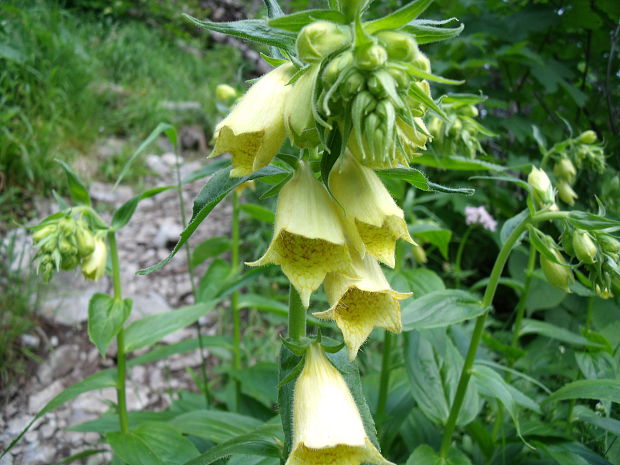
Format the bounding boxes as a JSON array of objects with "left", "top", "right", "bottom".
[{"left": 183, "top": 14, "right": 295, "bottom": 49}]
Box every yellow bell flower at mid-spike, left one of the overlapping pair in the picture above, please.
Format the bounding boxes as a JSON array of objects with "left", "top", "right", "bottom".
[{"left": 248, "top": 161, "right": 355, "bottom": 307}]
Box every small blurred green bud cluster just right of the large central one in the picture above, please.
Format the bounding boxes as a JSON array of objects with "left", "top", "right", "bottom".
[{"left": 428, "top": 104, "right": 494, "bottom": 158}]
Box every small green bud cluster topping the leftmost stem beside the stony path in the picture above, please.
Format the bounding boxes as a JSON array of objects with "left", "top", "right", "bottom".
[{"left": 32, "top": 216, "right": 107, "bottom": 281}]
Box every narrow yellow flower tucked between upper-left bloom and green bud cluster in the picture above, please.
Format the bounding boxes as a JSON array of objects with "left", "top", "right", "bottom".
[{"left": 284, "top": 65, "right": 321, "bottom": 148}]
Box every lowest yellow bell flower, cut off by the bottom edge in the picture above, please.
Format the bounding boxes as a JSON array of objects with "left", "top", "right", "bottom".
[{"left": 286, "top": 344, "right": 392, "bottom": 465}]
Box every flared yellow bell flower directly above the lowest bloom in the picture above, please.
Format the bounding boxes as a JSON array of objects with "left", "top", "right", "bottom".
[{"left": 313, "top": 255, "right": 411, "bottom": 360}]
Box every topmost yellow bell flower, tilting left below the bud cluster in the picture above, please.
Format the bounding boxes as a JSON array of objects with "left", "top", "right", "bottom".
[{"left": 209, "top": 63, "right": 295, "bottom": 177}]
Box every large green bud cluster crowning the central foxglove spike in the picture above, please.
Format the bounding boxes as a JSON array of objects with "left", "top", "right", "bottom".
[{"left": 297, "top": 21, "right": 431, "bottom": 168}]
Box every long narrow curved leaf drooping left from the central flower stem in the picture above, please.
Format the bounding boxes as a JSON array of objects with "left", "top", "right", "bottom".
[{"left": 138, "top": 166, "right": 288, "bottom": 275}]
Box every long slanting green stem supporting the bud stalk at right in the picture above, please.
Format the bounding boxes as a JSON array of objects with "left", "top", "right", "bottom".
[{"left": 439, "top": 217, "right": 531, "bottom": 458}]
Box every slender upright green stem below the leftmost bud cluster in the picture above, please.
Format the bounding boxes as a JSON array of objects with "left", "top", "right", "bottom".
[{"left": 108, "top": 231, "right": 129, "bottom": 433}]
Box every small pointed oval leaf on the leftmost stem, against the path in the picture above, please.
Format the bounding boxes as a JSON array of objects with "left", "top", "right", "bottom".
[{"left": 88, "top": 293, "right": 132, "bottom": 357}]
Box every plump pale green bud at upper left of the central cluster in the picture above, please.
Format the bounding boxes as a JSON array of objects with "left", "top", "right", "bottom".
[{"left": 296, "top": 21, "right": 351, "bottom": 63}]
